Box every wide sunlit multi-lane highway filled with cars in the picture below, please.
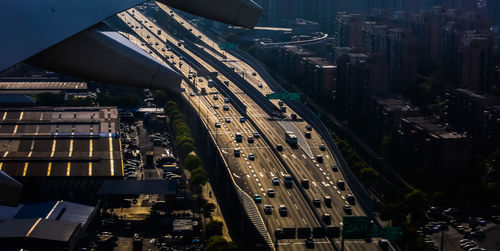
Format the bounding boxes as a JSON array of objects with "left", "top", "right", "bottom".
[{"left": 119, "top": 4, "right": 377, "bottom": 250}]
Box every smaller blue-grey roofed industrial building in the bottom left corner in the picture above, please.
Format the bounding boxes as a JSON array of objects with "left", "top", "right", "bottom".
[{"left": 0, "top": 201, "right": 96, "bottom": 250}]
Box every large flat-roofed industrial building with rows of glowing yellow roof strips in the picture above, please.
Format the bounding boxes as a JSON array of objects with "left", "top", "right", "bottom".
[{"left": 0, "top": 107, "right": 123, "bottom": 200}]
